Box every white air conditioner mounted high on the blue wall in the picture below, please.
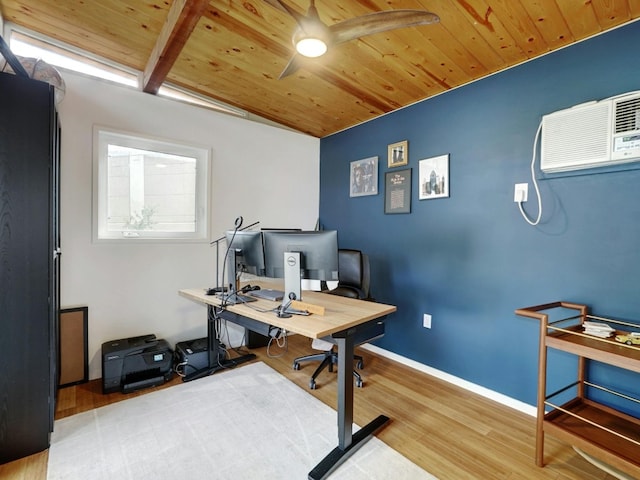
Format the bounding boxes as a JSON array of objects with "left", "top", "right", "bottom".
[{"left": 540, "top": 92, "right": 640, "bottom": 172}]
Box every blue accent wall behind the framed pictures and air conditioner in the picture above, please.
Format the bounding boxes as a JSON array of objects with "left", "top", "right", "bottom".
[{"left": 320, "top": 22, "right": 640, "bottom": 405}]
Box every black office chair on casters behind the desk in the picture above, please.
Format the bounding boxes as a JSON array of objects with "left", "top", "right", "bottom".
[{"left": 293, "top": 249, "right": 373, "bottom": 390}]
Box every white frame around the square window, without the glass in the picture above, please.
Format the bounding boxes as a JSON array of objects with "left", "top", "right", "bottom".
[{"left": 93, "top": 125, "right": 211, "bottom": 243}]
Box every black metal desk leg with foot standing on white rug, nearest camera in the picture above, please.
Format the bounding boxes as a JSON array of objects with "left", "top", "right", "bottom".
[{"left": 309, "top": 333, "right": 389, "bottom": 480}]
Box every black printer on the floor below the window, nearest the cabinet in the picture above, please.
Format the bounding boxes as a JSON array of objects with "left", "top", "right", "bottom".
[{"left": 102, "top": 334, "right": 173, "bottom": 393}]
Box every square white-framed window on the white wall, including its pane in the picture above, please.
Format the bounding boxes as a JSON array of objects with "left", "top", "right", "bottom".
[{"left": 93, "top": 127, "right": 209, "bottom": 241}]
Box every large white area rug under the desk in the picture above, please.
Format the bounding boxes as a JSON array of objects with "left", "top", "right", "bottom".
[{"left": 47, "top": 362, "right": 435, "bottom": 480}]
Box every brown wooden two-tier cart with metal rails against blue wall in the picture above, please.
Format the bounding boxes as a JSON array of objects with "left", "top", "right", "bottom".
[{"left": 515, "top": 302, "right": 640, "bottom": 478}]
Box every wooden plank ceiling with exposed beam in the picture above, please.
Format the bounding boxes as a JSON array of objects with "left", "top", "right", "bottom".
[{"left": 0, "top": 0, "right": 640, "bottom": 137}]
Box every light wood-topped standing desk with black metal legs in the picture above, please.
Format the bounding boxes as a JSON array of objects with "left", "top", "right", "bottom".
[{"left": 178, "top": 285, "right": 396, "bottom": 480}]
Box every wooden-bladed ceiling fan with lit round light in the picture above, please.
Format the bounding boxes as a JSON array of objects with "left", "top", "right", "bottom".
[{"left": 265, "top": 0, "right": 440, "bottom": 79}]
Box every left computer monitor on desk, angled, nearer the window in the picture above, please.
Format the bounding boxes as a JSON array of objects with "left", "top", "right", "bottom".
[{"left": 225, "top": 230, "right": 264, "bottom": 291}]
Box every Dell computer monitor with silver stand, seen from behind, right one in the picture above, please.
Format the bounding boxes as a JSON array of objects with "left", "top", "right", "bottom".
[{"left": 262, "top": 230, "right": 338, "bottom": 300}]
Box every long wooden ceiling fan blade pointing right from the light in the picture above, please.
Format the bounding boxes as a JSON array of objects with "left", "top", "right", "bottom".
[{"left": 329, "top": 10, "right": 440, "bottom": 45}]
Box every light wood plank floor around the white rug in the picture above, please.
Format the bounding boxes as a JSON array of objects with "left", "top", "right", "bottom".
[{"left": 0, "top": 336, "right": 615, "bottom": 480}]
